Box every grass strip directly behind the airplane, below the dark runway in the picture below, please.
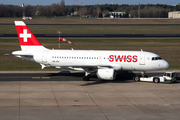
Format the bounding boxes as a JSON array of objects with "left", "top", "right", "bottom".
[{"left": 0, "top": 39, "right": 180, "bottom": 71}]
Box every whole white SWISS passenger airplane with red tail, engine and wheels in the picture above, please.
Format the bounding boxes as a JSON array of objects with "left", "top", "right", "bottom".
[{"left": 12, "top": 21, "right": 169, "bottom": 81}]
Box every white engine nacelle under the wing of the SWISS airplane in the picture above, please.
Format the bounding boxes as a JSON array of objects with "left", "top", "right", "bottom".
[{"left": 96, "top": 68, "right": 116, "bottom": 80}]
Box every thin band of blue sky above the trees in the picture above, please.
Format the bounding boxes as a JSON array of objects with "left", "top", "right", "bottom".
[{"left": 0, "top": 0, "right": 180, "bottom": 5}]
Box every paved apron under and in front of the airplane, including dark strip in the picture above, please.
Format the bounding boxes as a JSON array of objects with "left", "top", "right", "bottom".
[{"left": 0, "top": 72, "right": 180, "bottom": 120}]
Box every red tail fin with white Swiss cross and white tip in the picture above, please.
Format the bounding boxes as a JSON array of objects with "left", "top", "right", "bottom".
[{"left": 14, "top": 21, "right": 46, "bottom": 51}]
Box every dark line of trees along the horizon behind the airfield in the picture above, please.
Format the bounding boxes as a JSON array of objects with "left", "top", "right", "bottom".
[{"left": 0, "top": 0, "right": 180, "bottom": 18}]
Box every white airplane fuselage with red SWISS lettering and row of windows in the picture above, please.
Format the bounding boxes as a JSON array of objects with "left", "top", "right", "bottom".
[{"left": 25, "top": 50, "right": 169, "bottom": 71}]
